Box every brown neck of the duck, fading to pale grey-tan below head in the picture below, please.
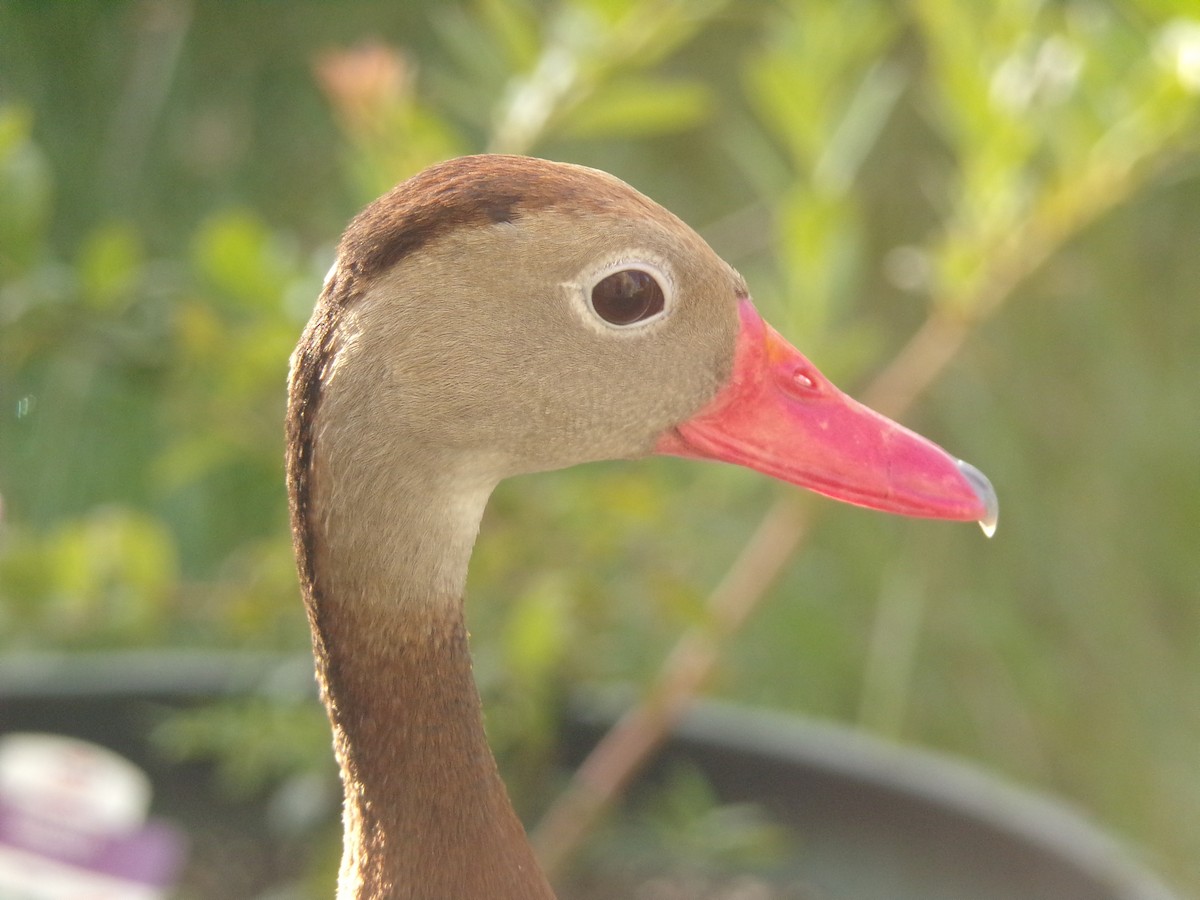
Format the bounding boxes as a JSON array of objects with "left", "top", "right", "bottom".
[{"left": 310, "top": 470, "right": 553, "bottom": 900}]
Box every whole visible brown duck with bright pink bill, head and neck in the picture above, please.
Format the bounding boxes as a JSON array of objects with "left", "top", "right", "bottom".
[{"left": 286, "top": 155, "right": 997, "bottom": 900}]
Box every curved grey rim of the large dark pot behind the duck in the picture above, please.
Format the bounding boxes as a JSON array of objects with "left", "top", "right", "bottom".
[{"left": 0, "top": 650, "right": 1180, "bottom": 900}]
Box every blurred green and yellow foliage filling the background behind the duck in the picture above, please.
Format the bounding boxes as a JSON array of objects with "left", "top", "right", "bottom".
[{"left": 0, "top": 0, "right": 1200, "bottom": 892}]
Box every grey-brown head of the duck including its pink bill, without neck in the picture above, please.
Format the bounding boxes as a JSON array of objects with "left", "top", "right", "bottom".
[{"left": 307, "top": 156, "right": 996, "bottom": 529}]
